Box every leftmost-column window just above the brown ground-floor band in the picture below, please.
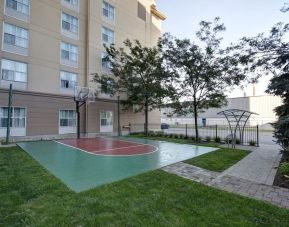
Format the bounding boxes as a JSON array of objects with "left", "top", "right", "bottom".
[{"left": 1, "top": 59, "right": 27, "bottom": 83}]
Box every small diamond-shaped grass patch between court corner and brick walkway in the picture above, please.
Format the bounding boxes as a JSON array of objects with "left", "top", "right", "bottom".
[{"left": 185, "top": 148, "right": 249, "bottom": 172}]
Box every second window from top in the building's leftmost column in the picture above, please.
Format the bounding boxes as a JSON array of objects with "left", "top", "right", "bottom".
[{"left": 4, "top": 23, "right": 28, "bottom": 49}]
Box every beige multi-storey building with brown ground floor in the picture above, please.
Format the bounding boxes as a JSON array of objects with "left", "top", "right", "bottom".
[{"left": 0, "top": 0, "right": 165, "bottom": 137}]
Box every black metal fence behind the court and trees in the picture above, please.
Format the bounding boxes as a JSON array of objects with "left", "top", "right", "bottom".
[{"left": 126, "top": 124, "right": 259, "bottom": 146}]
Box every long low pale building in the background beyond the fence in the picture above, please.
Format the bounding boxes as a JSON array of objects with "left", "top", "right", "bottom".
[{"left": 162, "top": 95, "right": 282, "bottom": 129}]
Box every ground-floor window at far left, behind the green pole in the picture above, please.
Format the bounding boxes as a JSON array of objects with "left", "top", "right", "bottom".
[{"left": 0, "top": 107, "right": 26, "bottom": 128}]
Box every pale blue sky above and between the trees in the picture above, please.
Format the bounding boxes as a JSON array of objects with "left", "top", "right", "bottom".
[{"left": 157, "top": 0, "right": 289, "bottom": 97}]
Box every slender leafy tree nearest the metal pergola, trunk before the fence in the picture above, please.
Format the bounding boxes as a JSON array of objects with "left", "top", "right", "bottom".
[{"left": 160, "top": 18, "right": 245, "bottom": 139}]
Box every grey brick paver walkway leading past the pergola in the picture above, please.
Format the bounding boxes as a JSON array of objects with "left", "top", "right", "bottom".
[{"left": 163, "top": 145, "right": 289, "bottom": 209}]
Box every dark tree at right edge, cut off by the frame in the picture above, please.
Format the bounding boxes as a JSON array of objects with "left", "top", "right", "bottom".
[{"left": 238, "top": 19, "right": 289, "bottom": 154}]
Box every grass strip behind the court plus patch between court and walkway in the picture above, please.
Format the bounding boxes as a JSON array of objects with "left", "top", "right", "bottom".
[{"left": 131, "top": 135, "right": 249, "bottom": 172}]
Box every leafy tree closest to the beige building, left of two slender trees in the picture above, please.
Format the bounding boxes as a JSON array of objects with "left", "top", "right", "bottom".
[{"left": 94, "top": 40, "right": 169, "bottom": 135}]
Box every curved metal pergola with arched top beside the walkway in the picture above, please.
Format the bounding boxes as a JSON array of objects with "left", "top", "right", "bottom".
[{"left": 217, "top": 109, "right": 259, "bottom": 148}]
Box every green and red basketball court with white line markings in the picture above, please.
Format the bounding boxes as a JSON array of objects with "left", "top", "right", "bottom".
[{"left": 18, "top": 137, "right": 216, "bottom": 192}]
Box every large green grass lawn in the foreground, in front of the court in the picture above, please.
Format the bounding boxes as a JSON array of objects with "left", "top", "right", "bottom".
[{"left": 0, "top": 148, "right": 289, "bottom": 226}]
